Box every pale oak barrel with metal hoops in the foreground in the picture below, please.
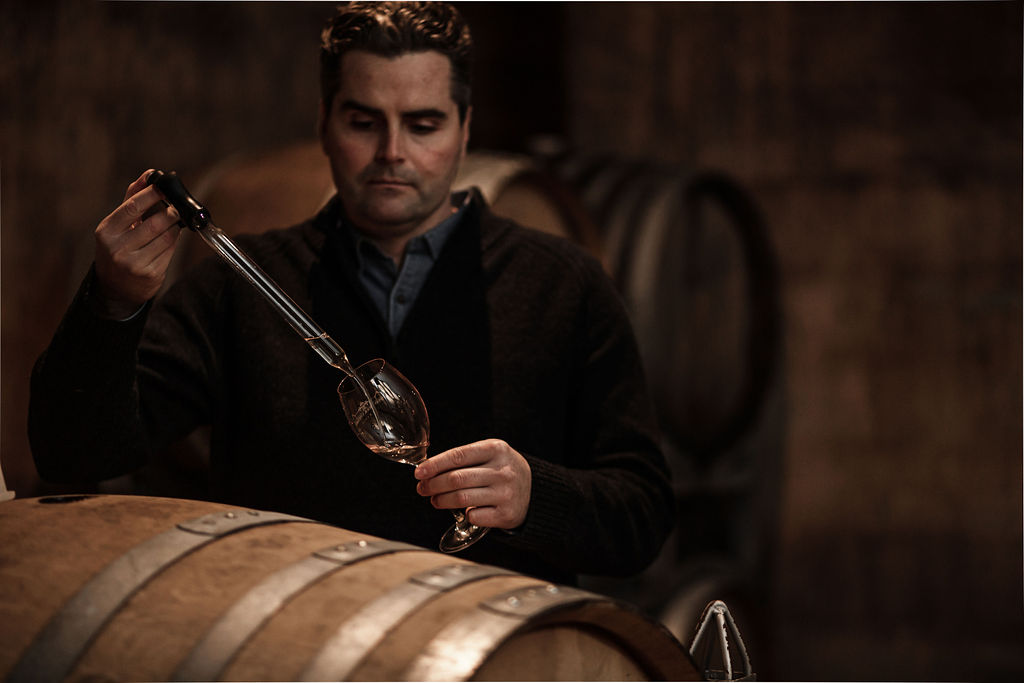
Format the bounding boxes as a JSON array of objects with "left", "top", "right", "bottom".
[{"left": 0, "top": 496, "right": 699, "bottom": 681}]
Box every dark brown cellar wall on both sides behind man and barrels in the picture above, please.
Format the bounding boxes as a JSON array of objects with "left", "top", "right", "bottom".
[{"left": 0, "top": 1, "right": 1024, "bottom": 680}]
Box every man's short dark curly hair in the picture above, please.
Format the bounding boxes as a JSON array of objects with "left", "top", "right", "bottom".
[{"left": 319, "top": 2, "right": 473, "bottom": 121}]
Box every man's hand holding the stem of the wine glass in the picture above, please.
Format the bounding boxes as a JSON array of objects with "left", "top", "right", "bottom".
[{"left": 416, "top": 438, "right": 531, "bottom": 528}]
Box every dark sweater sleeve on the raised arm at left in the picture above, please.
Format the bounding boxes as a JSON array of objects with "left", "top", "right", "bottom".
[{"left": 29, "top": 270, "right": 224, "bottom": 482}]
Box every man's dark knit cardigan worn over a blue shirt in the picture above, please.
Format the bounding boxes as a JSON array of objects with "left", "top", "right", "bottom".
[{"left": 29, "top": 189, "right": 673, "bottom": 583}]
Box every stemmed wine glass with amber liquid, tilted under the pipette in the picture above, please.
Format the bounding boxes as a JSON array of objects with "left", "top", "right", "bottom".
[{"left": 338, "top": 358, "right": 489, "bottom": 553}]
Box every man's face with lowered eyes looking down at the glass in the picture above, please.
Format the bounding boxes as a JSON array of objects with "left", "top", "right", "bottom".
[{"left": 319, "top": 50, "right": 469, "bottom": 245}]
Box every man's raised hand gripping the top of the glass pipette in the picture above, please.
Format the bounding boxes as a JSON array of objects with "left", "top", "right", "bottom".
[{"left": 95, "top": 169, "right": 181, "bottom": 316}]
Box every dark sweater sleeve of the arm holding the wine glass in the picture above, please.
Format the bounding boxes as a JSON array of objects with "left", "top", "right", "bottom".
[{"left": 491, "top": 255, "right": 675, "bottom": 575}]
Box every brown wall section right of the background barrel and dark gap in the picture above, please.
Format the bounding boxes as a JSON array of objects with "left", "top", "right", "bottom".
[{"left": 566, "top": 2, "right": 1024, "bottom": 680}]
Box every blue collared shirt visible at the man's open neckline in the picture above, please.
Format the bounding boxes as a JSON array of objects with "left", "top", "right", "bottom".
[{"left": 350, "top": 193, "right": 469, "bottom": 339}]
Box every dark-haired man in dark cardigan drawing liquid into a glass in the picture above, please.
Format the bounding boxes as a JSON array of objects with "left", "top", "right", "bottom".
[{"left": 30, "top": 3, "right": 673, "bottom": 583}]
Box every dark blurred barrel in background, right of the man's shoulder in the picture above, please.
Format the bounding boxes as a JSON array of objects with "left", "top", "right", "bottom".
[{"left": 550, "top": 155, "right": 781, "bottom": 465}]
